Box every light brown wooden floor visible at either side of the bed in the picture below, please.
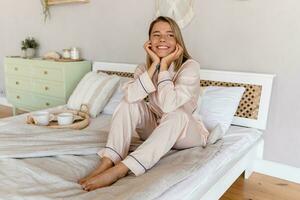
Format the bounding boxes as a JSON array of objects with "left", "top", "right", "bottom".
[{"left": 0, "top": 105, "right": 300, "bottom": 200}]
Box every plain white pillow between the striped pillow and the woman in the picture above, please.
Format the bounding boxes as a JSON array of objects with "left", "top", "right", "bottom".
[{"left": 102, "top": 77, "right": 130, "bottom": 115}]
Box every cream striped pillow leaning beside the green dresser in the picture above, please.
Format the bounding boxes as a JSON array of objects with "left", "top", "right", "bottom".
[{"left": 67, "top": 72, "right": 120, "bottom": 117}]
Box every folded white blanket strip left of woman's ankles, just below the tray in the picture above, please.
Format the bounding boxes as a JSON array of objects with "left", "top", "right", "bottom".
[{"left": 0, "top": 109, "right": 107, "bottom": 158}]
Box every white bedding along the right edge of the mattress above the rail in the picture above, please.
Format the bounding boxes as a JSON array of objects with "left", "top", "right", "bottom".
[{"left": 156, "top": 126, "right": 262, "bottom": 200}]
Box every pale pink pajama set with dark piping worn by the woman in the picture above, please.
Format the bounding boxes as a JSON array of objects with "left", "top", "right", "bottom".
[{"left": 98, "top": 59, "right": 209, "bottom": 176}]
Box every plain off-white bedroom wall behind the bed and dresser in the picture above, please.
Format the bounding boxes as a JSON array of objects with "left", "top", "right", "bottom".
[{"left": 0, "top": 0, "right": 300, "bottom": 167}]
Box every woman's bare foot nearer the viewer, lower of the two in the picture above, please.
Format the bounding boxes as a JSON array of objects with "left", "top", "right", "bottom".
[{"left": 82, "top": 162, "right": 129, "bottom": 191}]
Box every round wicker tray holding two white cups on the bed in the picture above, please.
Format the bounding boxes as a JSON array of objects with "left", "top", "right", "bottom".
[{"left": 26, "top": 105, "right": 90, "bottom": 130}]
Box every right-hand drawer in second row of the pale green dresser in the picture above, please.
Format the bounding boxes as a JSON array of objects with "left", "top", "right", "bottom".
[{"left": 32, "top": 80, "right": 65, "bottom": 98}]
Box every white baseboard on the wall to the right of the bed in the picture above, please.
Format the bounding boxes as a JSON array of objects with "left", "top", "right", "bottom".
[{"left": 254, "top": 160, "right": 300, "bottom": 184}]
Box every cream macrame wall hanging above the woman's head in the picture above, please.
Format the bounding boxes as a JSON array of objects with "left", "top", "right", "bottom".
[{"left": 156, "top": 0, "right": 194, "bottom": 28}]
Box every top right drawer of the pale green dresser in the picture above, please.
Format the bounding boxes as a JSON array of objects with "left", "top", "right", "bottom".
[{"left": 32, "top": 67, "right": 64, "bottom": 81}]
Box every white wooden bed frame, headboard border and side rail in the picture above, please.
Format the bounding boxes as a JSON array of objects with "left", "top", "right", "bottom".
[{"left": 93, "top": 62, "right": 275, "bottom": 200}]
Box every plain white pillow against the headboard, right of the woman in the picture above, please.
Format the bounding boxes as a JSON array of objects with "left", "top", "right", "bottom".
[{"left": 198, "top": 86, "right": 245, "bottom": 134}]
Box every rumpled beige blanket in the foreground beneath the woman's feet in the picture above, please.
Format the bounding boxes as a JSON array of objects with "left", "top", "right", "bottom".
[{"left": 0, "top": 148, "right": 220, "bottom": 200}]
